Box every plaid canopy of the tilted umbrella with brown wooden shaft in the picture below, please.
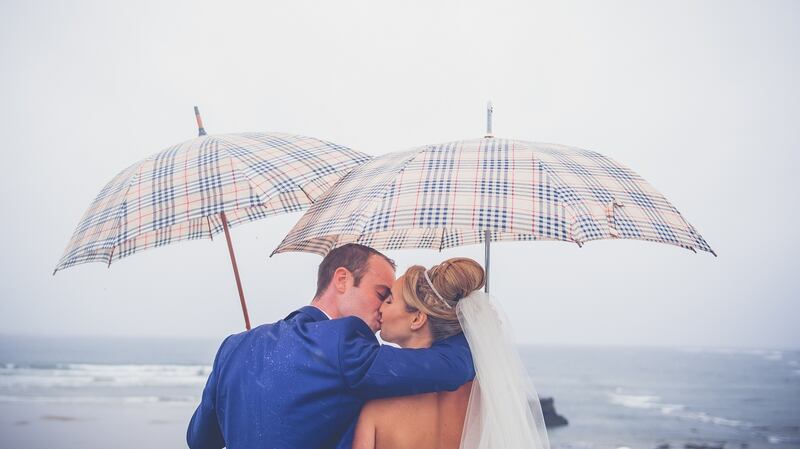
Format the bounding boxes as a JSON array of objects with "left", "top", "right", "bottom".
[{"left": 54, "top": 133, "right": 370, "bottom": 273}]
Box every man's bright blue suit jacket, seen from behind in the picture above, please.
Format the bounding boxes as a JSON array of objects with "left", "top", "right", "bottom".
[{"left": 186, "top": 306, "right": 475, "bottom": 449}]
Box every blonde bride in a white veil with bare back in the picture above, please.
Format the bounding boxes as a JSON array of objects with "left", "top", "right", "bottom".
[{"left": 353, "top": 258, "right": 550, "bottom": 449}]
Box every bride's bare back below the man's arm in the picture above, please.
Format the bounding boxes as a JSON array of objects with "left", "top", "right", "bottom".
[{"left": 353, "top": 382, "right": 472, "bottom": 449}]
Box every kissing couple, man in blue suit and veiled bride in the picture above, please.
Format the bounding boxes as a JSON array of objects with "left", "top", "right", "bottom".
[{"left": 187, "top": 244, "right": 549, "bottom": 449}]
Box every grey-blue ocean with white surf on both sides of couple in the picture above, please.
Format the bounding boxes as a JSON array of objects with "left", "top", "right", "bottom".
[{"left": 0, "top": 336, "right": 800, "bottom": 449}]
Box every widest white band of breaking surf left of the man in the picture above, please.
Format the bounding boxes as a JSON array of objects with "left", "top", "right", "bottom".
[{"left": 0, "top": 363, "right": 211, "bottom": 391}]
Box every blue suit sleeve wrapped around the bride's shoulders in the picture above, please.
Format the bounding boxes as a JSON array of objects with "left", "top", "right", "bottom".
[{"left": 339, "top": 318, "right": 475, "bottom": 399}]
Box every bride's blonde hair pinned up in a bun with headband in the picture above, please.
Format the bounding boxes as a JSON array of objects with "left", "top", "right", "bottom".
[{"left": 403, "top": 257, "right": 486, "bottom": 341}]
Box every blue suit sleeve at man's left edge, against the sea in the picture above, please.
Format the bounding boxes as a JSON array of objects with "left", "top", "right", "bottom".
[{"left": 186, "top": 337, "right": 230, "bottom": 449}]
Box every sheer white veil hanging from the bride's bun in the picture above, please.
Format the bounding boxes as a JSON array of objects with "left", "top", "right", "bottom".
[{"left": 456, "top": 290, "right": 550, "bottom": 449}]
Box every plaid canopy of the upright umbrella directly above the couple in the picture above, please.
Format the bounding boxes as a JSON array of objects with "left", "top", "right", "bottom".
[{"left": 273, "top": 138, "right": 713, "bottom": 255}]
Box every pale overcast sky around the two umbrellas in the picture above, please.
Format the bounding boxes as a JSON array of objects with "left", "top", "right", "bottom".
[{"left": 0, "top": 1, "right": 800, "bottom": 348}]
